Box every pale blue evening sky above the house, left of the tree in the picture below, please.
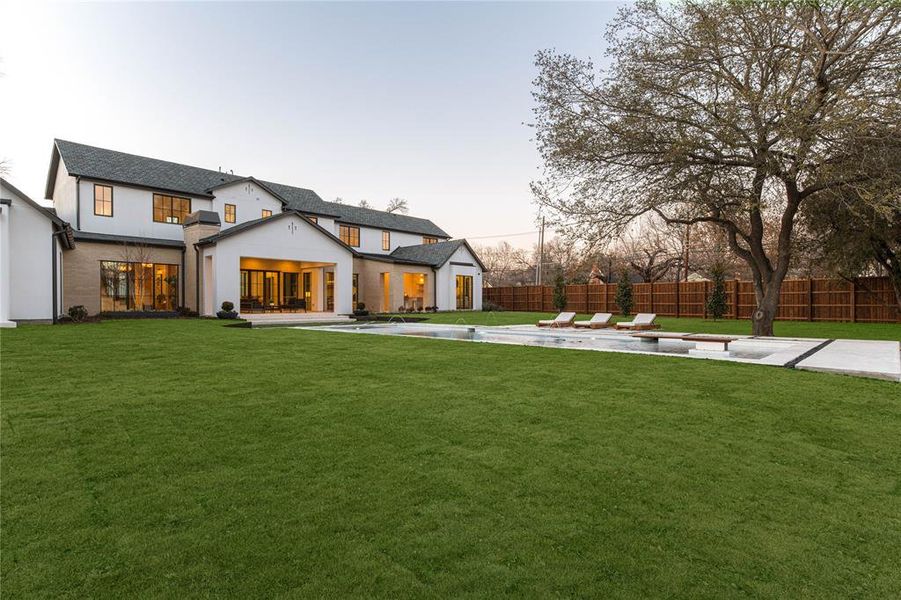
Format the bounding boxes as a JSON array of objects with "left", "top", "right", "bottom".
[{"left": 0, "top": 2, "right": 617, "bottom": 245}]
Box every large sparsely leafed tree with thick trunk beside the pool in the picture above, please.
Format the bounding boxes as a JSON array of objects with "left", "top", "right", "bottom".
[{"left": 533, "top": 0, "right": 901, "bottom": 335}]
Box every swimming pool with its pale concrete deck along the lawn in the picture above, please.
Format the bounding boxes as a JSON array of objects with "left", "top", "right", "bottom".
[{"left": 304, "top": 322, "right": 901, "bottom": 382}]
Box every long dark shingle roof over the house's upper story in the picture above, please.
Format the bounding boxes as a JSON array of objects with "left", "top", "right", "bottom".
[{"left": 46, "top": 140, "right": 450, "bottom": 238}]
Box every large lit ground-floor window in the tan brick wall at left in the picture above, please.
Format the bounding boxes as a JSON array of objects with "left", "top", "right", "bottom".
[{"left": 100, "top": 260, "right": 178, "bottom": 312}]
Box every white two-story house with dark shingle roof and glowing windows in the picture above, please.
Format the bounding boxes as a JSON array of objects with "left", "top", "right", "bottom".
[{"left": 35, "top": 140, "right": 484, "bottom": 318}]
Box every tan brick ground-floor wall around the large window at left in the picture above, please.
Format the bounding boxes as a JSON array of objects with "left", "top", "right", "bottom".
[{"left": 61, "top": 241, "right": 185, "bottom": 315}]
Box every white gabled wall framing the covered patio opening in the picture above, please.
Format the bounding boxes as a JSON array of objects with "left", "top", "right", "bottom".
[{"left": 202, "top": 215, "right": 353, "bottom": 315}]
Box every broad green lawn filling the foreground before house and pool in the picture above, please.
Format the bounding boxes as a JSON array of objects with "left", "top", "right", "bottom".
[{"left": 0, "top": 314, "right": 901, "bottom": 598}]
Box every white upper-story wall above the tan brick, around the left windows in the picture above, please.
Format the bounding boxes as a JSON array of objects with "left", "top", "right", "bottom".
[{"left": 74, "top": 179, "right": 213, "bottom": 241}]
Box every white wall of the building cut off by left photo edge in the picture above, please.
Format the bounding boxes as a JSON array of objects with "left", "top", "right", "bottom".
[{"left": 0, "top": 186, "right": 59, "bottom": 321}]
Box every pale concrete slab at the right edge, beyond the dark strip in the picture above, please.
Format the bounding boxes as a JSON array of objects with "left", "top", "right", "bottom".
[{"left": 795, "top": 340, "right": 901, "bottom": 381}]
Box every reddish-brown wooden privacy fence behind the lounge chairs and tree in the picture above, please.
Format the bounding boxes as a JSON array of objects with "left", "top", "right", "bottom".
[{"left": 482, "top": 277, "right": 901, "bottom": 323}]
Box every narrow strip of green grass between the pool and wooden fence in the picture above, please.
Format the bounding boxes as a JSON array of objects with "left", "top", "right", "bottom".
[{"left": 398, "top": 311, "right": 901, "bottom": 341}]
